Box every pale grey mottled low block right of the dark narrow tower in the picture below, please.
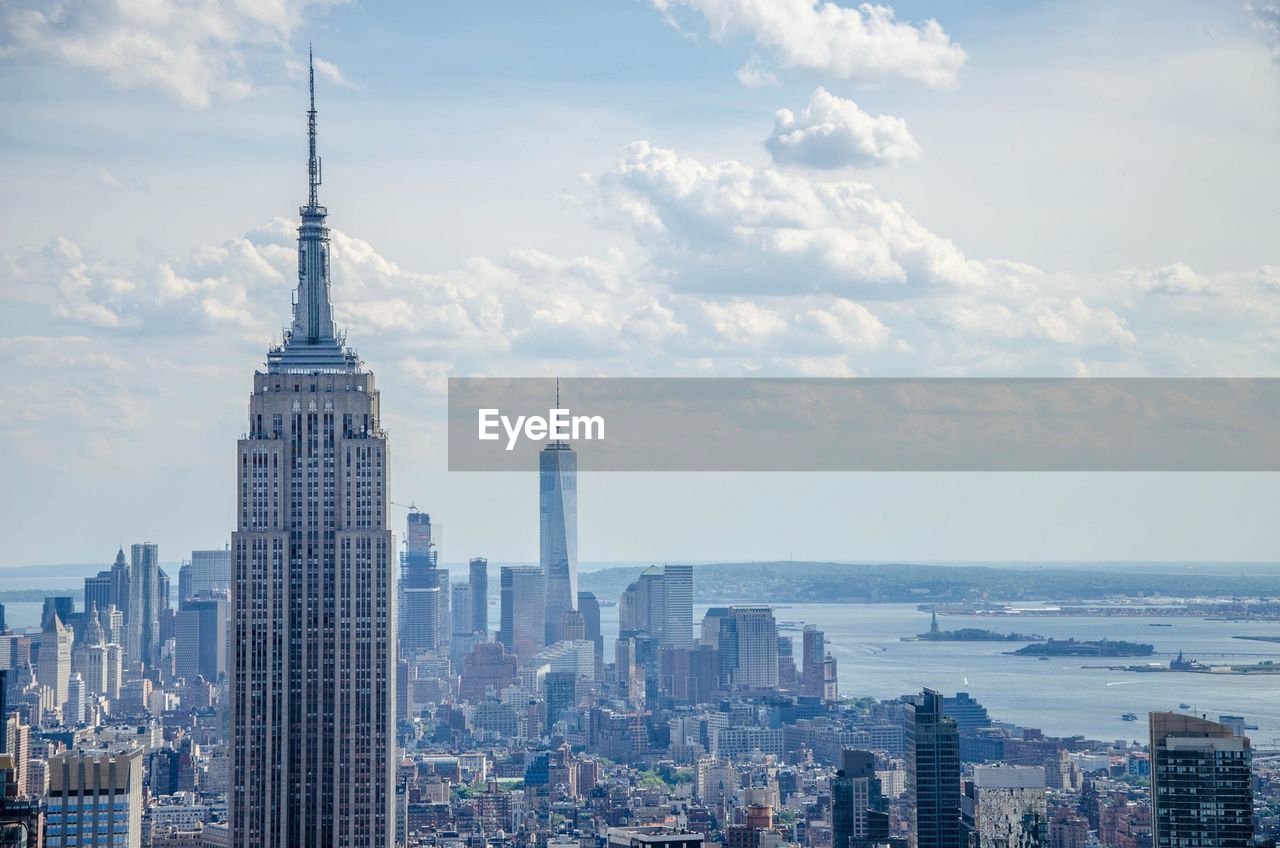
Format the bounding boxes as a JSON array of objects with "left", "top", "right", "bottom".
[{"left": 960, "top": 766, "right": 1048, "bottom": 848}]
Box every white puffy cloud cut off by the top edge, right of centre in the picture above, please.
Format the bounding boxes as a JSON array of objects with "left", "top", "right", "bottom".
[{"left": 653, "top": 0, "right": 965, "bottom": 88}]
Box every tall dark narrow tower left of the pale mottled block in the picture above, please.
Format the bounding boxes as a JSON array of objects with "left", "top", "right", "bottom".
[{"left": 906, "top": 689, "right": 964, "bottom": 848}]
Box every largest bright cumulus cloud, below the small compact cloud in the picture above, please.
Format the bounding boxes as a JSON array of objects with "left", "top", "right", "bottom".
[{"left": 600, "top": 141, "right": 987, "bottom": 297}]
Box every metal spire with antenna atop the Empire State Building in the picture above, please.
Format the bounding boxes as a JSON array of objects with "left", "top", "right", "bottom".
[{"left": 268, "top": 50, "right": 360, "bottom": 374}]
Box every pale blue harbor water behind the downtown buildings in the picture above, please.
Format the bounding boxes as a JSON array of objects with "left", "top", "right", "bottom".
[{"left": 5, "top": 589, "right": 1280, "bottom": 749}]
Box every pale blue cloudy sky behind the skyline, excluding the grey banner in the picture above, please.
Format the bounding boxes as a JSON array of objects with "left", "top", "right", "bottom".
[{"left": 0, "top": 0, "right": 1280, "bottom": 565}]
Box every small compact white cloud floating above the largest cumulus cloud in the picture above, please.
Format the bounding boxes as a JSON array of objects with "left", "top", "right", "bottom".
[{"left": 764, "top": 86, "right": 920, "bottom": 168}]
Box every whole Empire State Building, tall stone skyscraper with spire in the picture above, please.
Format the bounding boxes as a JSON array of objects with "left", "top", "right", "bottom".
[{"left": 228, "top": 56, "right": 397, "bottom": 848}]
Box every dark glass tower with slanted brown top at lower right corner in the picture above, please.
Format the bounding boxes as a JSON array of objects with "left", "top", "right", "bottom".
[{"left": 1149, "top": 712, "right": 1253, "bottom": 848}]
